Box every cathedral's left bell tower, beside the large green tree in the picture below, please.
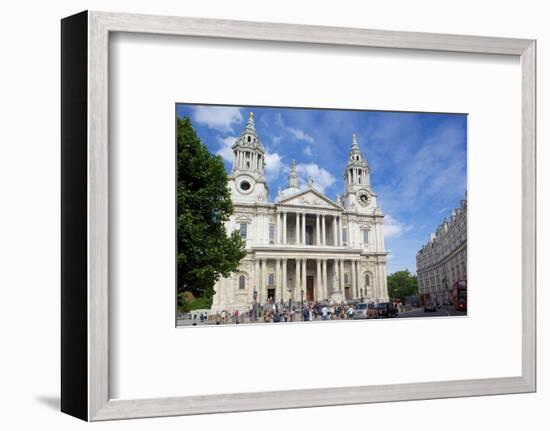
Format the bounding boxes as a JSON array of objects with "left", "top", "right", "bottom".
[{"left": 229, "top": 112, "right": 268, "bottom": 202}]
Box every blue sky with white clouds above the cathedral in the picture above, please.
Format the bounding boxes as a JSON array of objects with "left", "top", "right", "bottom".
[{"left": 176, "top": 104, "right": 467, "bottom": 274}]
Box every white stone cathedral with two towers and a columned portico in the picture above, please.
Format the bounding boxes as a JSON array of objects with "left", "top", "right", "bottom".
[{"left": 212, "top": 113, "right": 388, "bottom": 312}]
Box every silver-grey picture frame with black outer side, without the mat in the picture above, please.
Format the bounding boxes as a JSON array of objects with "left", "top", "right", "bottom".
[{"left": 61, "top": 11, "right": 536, "bottom": 421}]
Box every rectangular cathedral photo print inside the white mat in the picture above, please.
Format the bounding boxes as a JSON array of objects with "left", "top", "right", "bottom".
[{"left": 176, "top": 103, "right": 468, "bottom": 326}]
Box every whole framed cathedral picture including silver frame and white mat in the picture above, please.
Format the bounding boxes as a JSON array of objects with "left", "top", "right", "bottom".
[{"left": 61, "top": 12, "right": 536, "bottom": 421}]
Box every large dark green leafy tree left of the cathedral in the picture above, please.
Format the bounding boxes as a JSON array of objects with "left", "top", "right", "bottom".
[{"left": 176, "top": 117, "right": 246, "bottom": 311}]
